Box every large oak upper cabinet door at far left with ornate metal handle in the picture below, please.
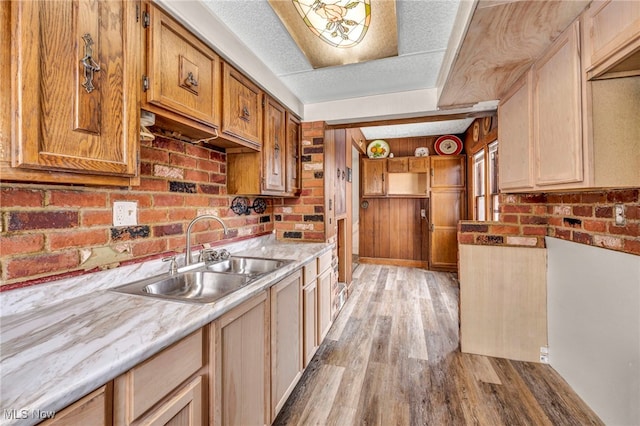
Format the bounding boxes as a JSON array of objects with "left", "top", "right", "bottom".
[{"left": 9, "top": 0, "right": 140, "bottom": 180}]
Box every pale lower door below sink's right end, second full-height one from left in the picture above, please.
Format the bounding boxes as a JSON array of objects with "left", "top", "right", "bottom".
[{"left": 271, "top": 271, "right": 303, "bottom": 419}]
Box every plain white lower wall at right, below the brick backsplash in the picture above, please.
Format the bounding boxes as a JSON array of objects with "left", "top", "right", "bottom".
[{"left": 546, "top": 237, "right": 640, "bottom": 425}]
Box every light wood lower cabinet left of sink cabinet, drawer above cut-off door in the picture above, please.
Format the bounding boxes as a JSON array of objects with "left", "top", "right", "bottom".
[{"left": 114, "top": 327, "right": 207, "bottom": 425}]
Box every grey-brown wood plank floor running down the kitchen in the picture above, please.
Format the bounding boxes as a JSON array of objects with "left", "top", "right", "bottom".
[{"left": 274, "top": 264, "right": 603, "bottom": 426}]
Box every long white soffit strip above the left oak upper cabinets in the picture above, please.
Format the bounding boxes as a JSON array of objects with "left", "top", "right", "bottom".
[{"left": 156, "top": 0, "right": 304, "bottom": 116}]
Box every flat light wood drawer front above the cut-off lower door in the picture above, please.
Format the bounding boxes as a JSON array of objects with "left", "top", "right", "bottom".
[{"left": 128, "top": 329, "right": 203, "bottom": 420}]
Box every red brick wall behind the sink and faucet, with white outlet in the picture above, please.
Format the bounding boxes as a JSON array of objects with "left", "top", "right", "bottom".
[{"left": 0, "top": 137, "right": 272, "bottom": 291}]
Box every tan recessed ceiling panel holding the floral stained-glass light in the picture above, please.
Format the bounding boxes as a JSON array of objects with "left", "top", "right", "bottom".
[{"left": 269, "top": 0, "right": 398, "bottom": 68}]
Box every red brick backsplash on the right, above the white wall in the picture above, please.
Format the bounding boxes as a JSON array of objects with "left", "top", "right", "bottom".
[{"left": 458, "top": 188, "right": 640, "bottom": 255}]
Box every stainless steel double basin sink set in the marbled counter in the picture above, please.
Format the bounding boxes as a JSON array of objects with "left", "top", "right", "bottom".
[{"left": 113, "top": 256, "right": 293, "bottom": 303}]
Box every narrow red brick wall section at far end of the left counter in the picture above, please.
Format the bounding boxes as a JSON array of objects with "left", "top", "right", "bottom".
[{"left": 273, "top": 121, "right": 325, "bottom": 242}]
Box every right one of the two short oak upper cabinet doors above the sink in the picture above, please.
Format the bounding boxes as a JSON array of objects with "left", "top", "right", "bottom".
[{"left": 222, "top": 62, "right": 263, "bottom": 150}]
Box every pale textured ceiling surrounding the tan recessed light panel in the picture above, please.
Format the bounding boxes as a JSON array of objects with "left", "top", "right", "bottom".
[{"left": 204, "top": 0, "right": 459, "bottom": 104}]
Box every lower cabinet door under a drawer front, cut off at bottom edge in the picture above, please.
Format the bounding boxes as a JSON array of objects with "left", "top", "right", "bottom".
[{"left": 139, "top": 376, "right": 205, "bottom": 426}]
